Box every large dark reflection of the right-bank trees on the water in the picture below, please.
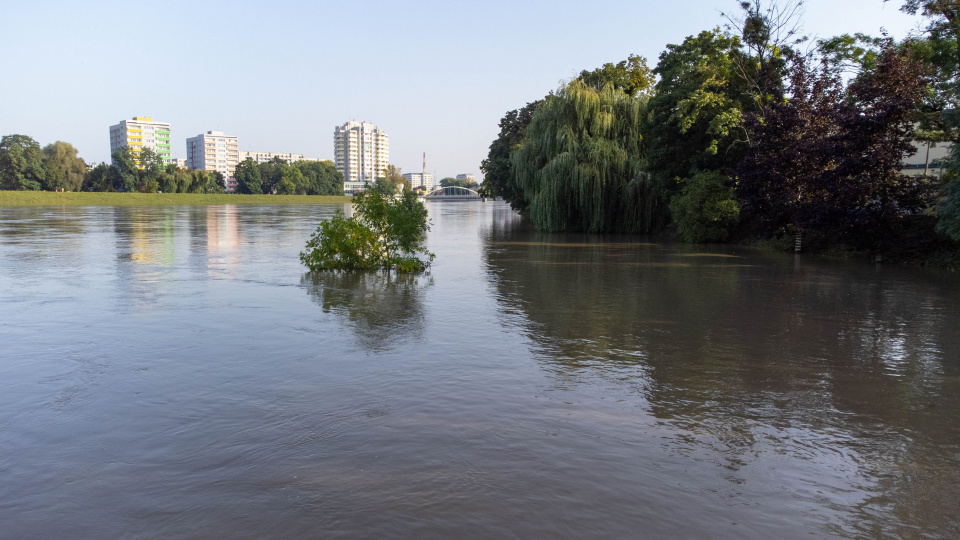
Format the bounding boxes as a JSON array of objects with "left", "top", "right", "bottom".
[{"left": 483, "top": 216, "right": 960, "bottom": 537}]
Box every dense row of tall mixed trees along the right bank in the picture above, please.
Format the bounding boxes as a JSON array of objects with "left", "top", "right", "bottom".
[{"left": 481, "top": 0, "right": 960, "bottom": 255}]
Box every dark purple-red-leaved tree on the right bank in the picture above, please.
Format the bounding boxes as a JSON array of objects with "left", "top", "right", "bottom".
[{"left": 737, "top": 42, "right": 927, "bottom": 252}]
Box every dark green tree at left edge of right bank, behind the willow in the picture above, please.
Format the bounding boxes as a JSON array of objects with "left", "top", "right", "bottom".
[{"left": 480, "top": 100, "right": 543, "bottom": 205}]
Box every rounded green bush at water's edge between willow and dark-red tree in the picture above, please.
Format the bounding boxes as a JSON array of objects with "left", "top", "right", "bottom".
[{"left": 670, "top": 172, "right": 740, "bottom": 243}]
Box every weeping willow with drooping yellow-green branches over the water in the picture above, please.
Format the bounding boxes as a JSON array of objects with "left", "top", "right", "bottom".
[{"left": 510, "top": 80, "right": 666, "bottom": 233}]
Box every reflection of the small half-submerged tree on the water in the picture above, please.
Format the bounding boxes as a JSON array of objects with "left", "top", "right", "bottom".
[{"left": 300, "top": 272, "right": 433, "bottom": 352}]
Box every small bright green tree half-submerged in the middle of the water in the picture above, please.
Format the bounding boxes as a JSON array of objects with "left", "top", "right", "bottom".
[{"left": 300, "top": 189, "right": 434, "bottom": 272}]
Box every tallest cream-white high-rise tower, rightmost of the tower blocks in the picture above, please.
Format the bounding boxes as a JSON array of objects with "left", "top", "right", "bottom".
[{"left": 333, "top": 121, "right": 390, "bottom": 194}]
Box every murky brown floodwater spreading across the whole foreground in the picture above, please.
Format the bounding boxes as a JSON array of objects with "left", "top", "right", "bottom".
[{"left": 0, "top": 202, "right": 960, "bottom": 539}]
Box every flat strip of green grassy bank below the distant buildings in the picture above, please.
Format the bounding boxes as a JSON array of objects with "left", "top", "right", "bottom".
[{"left": 0, "top": 191, "right": 351, "bottom": 206}]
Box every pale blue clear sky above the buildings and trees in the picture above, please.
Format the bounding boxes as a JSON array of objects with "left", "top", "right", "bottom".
[{"left": 0, "top": 0, "right": 920, "bottom": 178}]
